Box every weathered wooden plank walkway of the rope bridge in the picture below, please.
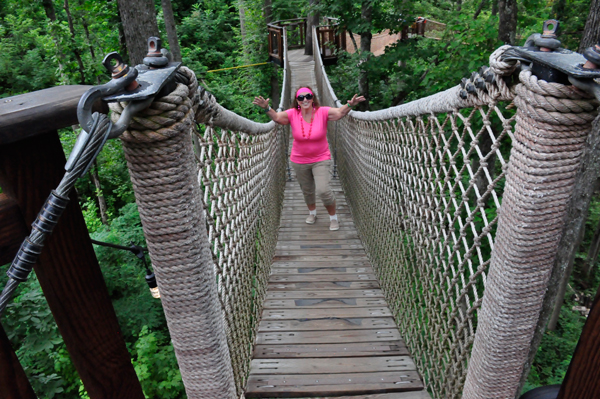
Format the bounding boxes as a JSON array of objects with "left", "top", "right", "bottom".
[{"left": 241, "top": 49, "right": 430, "bottom": 399}]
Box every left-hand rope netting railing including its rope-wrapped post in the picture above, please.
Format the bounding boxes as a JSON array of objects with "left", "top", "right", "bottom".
[{"left": 111, "top": 32, "right": 291, "bottom": 399}]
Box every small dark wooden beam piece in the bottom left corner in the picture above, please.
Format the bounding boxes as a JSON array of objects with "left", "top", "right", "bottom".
[{"left": 0, "top": 325, "right": 37, "bottom": 399}]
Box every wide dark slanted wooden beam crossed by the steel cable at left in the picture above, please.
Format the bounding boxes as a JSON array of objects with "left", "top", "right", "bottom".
[{"left": 0, "top": 132, "right": 144, "bottom": 399}]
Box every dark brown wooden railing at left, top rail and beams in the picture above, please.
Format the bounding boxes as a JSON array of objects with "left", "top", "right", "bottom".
[{"left": 0, "top": 86, "right": 144, "bottom": 399}]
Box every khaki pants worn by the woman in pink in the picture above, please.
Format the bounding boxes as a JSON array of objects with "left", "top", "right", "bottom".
[{"left": 290, "top": 159, "right": 335, "bottom": 206}]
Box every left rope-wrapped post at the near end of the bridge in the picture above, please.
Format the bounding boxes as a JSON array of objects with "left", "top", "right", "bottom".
[{"left": 111, "top": 67, "right": 236, "bottom": 399}]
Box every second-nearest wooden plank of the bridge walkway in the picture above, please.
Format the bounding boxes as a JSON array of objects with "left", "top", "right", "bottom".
[{"left": 250, "top": 356, "right": 417, "bottom": 375}]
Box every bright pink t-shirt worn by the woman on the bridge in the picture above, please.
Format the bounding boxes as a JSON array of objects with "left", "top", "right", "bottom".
[{"left": 285, "top": 107, "right": 331, "bottom": 163}]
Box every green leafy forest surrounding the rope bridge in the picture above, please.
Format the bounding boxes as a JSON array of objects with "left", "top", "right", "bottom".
[{"left": 0, "top": 0, "right": 600, "bottom": 398}]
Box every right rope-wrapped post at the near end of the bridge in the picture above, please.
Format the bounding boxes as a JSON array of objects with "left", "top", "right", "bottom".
[{"left": 463, "top": 70, "right": 597, "bottom": 399}]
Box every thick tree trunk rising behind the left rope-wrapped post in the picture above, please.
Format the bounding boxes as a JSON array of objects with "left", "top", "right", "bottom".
[{"left": 117, "top": 0, "right": 159, "bottom": 65}]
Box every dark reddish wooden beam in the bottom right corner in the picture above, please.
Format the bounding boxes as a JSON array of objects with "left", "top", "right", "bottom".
[{"left": 557, "top": 287, "right": 600, "bottom": 399}]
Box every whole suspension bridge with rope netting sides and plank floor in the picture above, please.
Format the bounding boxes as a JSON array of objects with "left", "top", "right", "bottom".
[{"left": 1, "top": 17, "right": 598, "bottom": 399}]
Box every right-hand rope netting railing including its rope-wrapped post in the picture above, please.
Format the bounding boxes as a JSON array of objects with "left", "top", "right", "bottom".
[{"left": 314, "top": 26, "right": 597, "bottom": 399}]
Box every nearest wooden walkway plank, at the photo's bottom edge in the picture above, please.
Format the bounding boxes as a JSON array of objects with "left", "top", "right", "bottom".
[{"left": 246, "top": 371, "right": 423, "bottom": 399}]
